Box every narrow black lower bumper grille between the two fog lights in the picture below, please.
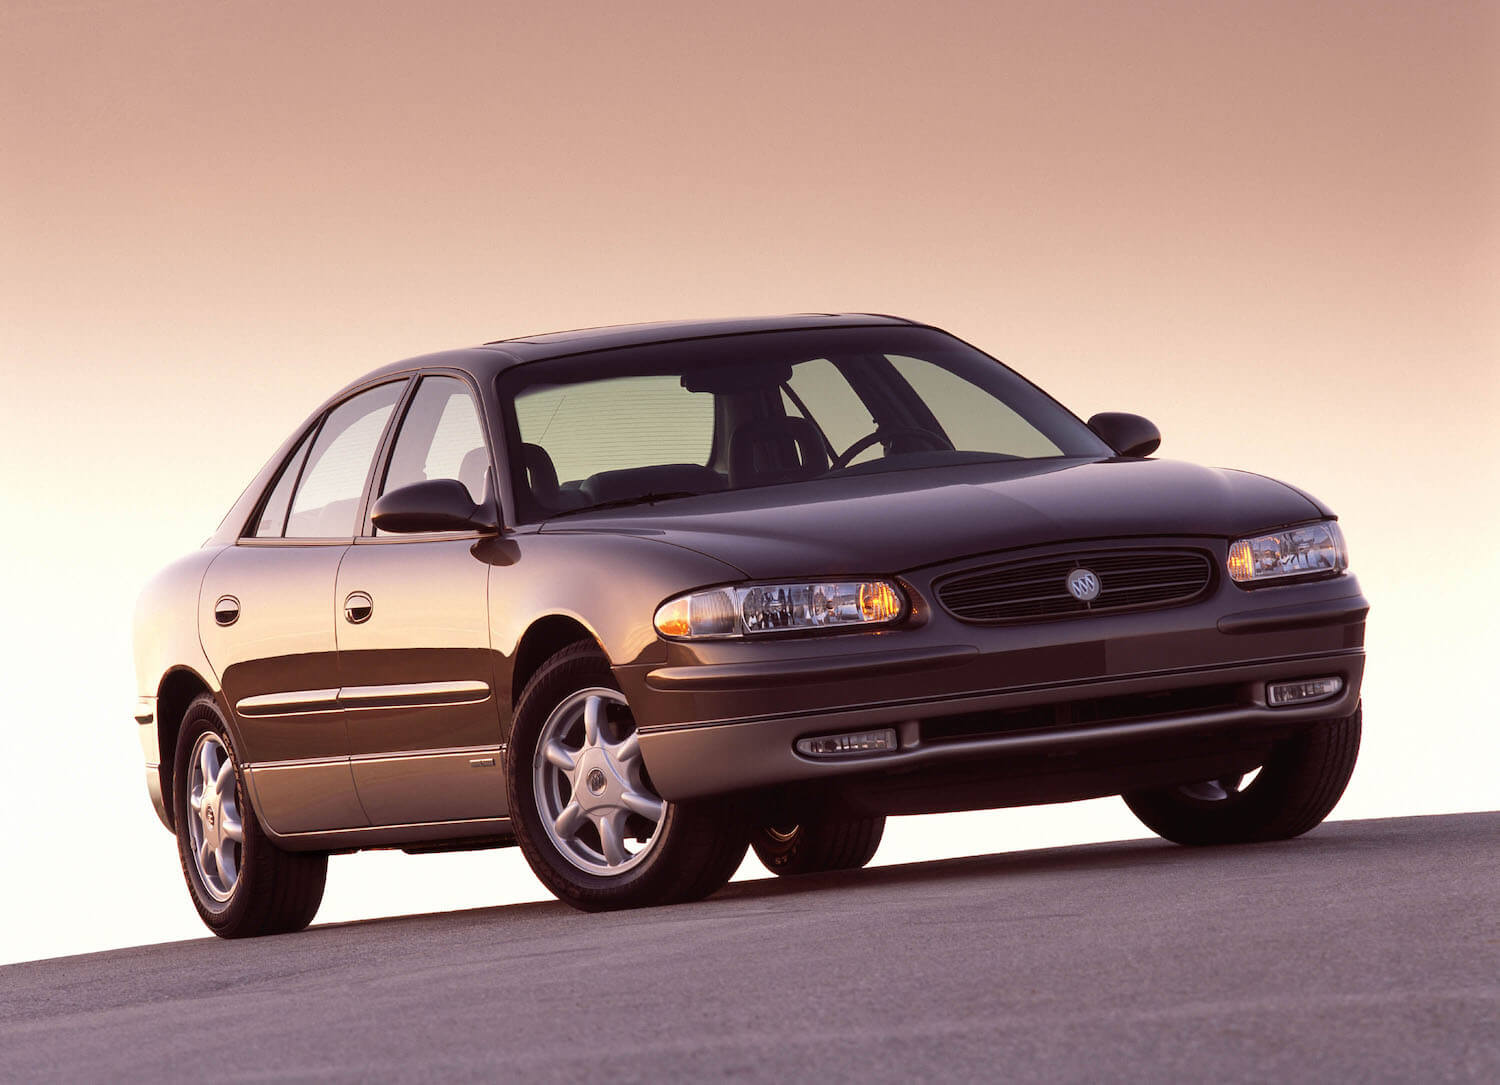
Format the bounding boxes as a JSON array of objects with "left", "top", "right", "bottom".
[{"left": 921, "top": 686, "right": 1244, "bottom": 743}]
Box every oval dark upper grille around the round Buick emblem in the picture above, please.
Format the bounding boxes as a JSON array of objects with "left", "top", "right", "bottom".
[{"left": 936, "top": 549, "right": 1214, "bottom": 623}]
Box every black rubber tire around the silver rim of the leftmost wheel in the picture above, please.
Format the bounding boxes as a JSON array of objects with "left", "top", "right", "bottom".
[{"left": 173, "top": 693, "right": 329, "bottom": 938}]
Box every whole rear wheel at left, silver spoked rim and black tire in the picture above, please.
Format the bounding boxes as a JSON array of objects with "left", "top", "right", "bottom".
[{"left": 173, "top": 693, "right": 329, "bottom": 938}]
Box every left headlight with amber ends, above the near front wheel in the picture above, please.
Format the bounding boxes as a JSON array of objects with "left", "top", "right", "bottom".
[{"left": 656, "top": 581, "right": 906, "bottom": 641}]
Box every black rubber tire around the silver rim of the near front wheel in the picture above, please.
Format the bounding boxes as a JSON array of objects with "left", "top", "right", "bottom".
[{"left": 506, "top": 644, "right": 749, "bottom": 911}]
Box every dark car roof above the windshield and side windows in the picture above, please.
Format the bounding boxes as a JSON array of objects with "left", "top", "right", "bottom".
[{"left": 341, "top": 312, "right": 915, "bottom": 395}]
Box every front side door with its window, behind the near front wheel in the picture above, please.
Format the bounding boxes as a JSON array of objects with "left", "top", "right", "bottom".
[{"left": 336, "top": 374, "right": 506, "bottom": 825}]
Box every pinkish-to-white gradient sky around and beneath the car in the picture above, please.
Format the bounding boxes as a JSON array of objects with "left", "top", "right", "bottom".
[{"left": 0, "top": 0, "right": 1500, "bottom": 960}]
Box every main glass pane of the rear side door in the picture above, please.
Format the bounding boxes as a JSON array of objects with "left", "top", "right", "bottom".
[{"left": 287, "top": 381, "right": 405, "bottom": 539}]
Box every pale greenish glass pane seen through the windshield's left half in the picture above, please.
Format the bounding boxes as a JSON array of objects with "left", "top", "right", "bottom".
[{"left": 516, "top": 374, "right": 714, "bottom": 483}]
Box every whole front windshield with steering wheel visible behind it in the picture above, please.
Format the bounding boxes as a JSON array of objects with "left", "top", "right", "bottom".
[{"left": 500, "top": 327, "right": 1112, "bottom": 522}]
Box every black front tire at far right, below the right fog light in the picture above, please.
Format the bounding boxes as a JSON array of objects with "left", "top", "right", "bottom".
[{"left": 1124, "top": 707, "right": 1362, "bottom": 845}]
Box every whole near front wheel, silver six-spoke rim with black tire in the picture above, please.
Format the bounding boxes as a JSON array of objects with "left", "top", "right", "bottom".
[{"left": 506, "top": 644, "right": 749, "bottom": 911}]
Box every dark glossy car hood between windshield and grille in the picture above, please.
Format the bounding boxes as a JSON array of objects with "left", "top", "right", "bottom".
[{"left": 542, "top": 459, "right": 1331, "bottom": 578}]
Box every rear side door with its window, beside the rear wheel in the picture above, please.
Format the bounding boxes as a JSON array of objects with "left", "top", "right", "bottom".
[{"left": 198, "top": 380, "right": 407, "bottom": 833}]
